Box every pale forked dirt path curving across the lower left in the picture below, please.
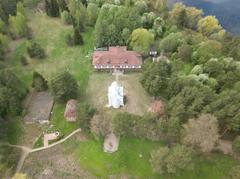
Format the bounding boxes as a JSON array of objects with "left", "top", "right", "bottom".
[{"left": 0, "top": 128, "right": 81, "bottom": 173}]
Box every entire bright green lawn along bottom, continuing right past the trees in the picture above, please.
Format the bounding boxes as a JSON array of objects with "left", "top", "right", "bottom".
[{"left": 63, "top": 138, "right": 239, "bottom": 179}]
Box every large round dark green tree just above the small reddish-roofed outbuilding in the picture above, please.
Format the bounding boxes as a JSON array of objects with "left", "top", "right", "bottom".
[{"left": 51, "top": 71, "right": 79, "bottom": 102}]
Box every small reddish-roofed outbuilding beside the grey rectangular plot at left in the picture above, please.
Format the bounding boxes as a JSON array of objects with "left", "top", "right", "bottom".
[{"left": 64, "top": 99, "right": 77, "bottom": 122}]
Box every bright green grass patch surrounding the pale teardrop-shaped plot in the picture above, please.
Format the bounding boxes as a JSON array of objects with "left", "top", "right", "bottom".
[{"left": 64, "top": 138, "right": 163, "bottom": 178}]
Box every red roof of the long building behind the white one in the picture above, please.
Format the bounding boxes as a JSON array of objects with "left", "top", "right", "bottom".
[{"left": 92, "top": 46, "right": 142, "bottom": 65}]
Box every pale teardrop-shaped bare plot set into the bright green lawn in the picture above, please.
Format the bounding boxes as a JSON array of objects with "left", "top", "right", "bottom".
[{"left": 103, "top": 133, "right": 119, "bottom": 153}]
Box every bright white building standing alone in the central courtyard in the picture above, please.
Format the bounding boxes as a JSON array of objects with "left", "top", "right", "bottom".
[{"left": 108, "top": 81, "right": 124, "bottom": 108}]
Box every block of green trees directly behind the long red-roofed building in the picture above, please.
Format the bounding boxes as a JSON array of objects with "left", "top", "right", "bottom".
[{"left": 95, "top": 4, "right": 140, "bottom": 47}]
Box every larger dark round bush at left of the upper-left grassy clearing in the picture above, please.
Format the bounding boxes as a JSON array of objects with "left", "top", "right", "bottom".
[{"left": 27, "top": 41, "right": 46, "bottom": 59}]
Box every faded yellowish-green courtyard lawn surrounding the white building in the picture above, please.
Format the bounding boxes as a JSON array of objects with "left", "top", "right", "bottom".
[{"left": 87, "top": 72, "right": 150, "bottom": 115}]
